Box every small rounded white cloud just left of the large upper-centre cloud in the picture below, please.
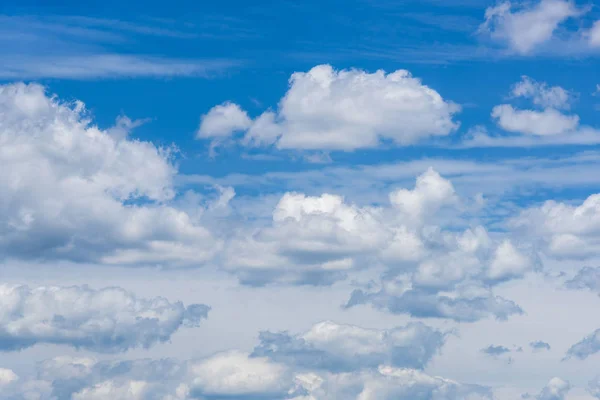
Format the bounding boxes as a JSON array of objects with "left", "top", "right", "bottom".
[{"left": 197, "top": 103, "right": 252, "bottom": 138}]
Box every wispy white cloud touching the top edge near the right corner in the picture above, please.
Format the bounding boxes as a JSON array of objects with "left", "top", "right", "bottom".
[{"left": 480, "top": 0, "right": 583, "bottom": 55}]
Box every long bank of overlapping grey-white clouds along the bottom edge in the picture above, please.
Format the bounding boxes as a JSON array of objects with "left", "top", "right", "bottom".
[{"left": 0, "top": 322, "right": 492, "bottom": 400}]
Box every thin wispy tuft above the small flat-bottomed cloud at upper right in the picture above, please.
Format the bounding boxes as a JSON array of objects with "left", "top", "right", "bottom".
[{"left": 512, "top": 76, "right": 573, "bottom": 109}]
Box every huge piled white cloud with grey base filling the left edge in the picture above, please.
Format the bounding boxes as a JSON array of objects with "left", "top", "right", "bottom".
[{"left": 0, "top": 84, "right": 219, "bottom": 265}]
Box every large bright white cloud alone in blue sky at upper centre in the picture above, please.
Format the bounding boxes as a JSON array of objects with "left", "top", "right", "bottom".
[{"left": 198, "top": 65, "right": 460, "bottom": 151}]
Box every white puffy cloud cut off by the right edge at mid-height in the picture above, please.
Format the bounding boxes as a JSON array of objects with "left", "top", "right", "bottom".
[{"left": 510, "top": 194, "right": 600, "bottom": 260}]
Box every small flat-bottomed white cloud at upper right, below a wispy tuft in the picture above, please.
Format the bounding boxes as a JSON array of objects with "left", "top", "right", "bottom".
[{"left": 492, "top": 104, "right": 579, "bottom": 136}]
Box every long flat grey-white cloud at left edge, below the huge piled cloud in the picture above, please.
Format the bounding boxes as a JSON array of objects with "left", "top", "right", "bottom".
[{"left": 0, "top": 285, "right": 210, "bottom": 353}]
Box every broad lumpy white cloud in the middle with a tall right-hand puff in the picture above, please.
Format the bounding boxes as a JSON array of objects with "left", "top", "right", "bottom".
[{"left": 222, "top": 169, "right": 534, "bottom": 292}]
